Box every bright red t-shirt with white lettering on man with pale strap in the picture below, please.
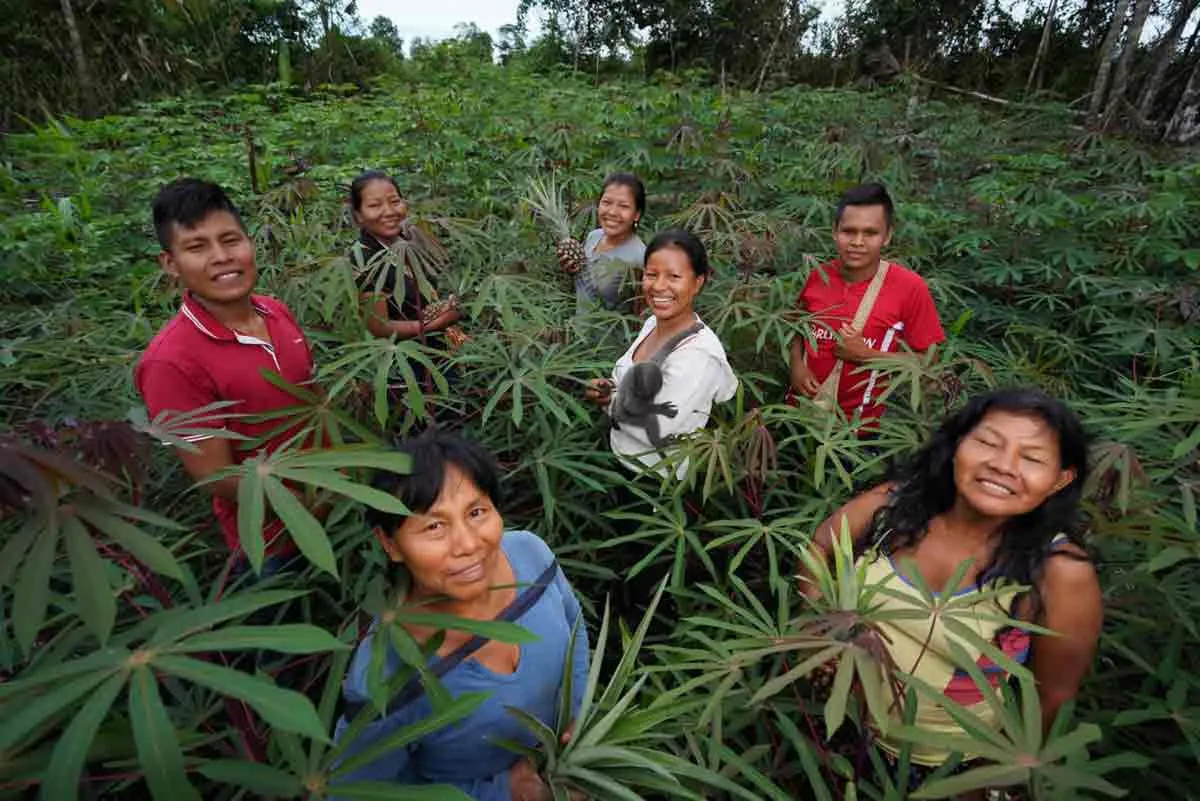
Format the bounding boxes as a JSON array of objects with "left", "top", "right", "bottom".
[{"left": 798, "top": 260, "right": 946, "bottom": 428}]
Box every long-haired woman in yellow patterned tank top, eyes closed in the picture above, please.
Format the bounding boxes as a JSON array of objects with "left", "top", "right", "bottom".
[{"left": 802, "top": 390, "right": 1103, "bottom": 797}]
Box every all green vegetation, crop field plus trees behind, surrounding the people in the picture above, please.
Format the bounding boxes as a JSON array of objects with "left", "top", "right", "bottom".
[{"left": 0, "top": 0, "right": 1200, "bottom": 801}]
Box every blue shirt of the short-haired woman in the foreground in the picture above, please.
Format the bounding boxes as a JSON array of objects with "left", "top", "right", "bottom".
[{"left": 334, "top": 531, "right": 589, "bottom": 801}]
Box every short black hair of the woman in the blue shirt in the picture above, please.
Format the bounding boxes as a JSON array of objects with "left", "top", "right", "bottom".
[{"left": 366, "top": 427, "right": 502, "bottom": 535}]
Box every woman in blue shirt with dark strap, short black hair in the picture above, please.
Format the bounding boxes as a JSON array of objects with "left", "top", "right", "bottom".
[{"left": 337, "top": 429, "right": 588, "bottom": 801}]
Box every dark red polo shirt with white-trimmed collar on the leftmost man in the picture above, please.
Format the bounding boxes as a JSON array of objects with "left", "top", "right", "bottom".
[{"left": 133, "top": 294, "right": 313, "bottom": 554}]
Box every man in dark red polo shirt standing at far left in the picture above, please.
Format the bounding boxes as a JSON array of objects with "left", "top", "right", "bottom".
[{"left": 133, "top": 179, "right": 313, "bottom": 556}]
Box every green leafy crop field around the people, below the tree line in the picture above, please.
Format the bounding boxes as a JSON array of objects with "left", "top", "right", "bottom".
[{"left": 0, "top": 65, "right": 1200, "bottom": 800}]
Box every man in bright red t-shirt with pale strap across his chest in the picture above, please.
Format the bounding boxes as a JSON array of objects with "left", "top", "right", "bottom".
[{"left": 792, "top": 183, "right": 946, "bottom": 433}]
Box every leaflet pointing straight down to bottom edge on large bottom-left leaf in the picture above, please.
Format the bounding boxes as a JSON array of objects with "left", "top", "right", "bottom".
[{"left": 130, "top": 664, "right": 200, "bottom": 801}]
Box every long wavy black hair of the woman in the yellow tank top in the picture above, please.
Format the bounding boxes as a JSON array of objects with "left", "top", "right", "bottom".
[{"left": 866, "top": 387, "right": 1088, "bottom": 619}]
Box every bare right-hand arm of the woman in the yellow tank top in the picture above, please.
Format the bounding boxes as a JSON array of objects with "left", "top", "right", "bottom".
[{"left": 1033, "top": 546, "right": 1104, "bottom": 730}]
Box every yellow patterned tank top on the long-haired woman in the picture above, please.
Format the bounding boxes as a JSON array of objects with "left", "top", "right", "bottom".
[{"left": 862, "top": 535, "right": 1067, "bottom": 765}]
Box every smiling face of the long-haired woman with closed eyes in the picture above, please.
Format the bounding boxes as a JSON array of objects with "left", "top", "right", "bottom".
[{"left": 954, "top": 409, "right": 1075, "bottom": 518}]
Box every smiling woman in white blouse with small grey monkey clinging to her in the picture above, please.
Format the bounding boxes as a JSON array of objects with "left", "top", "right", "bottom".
[{"left": 587, "top": 228, "right": 738, "bottom": 478}]
